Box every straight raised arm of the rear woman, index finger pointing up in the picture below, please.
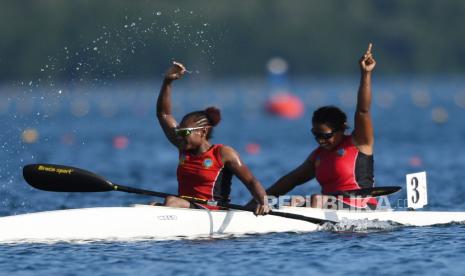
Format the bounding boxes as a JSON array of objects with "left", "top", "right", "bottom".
[{"left": 353, "top": 43, "right": 376, "bottom": 155}]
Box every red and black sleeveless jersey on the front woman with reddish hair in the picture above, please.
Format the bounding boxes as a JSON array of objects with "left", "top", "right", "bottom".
[{"left": 177, "top": 145, "right": 232, "bottom": 209}]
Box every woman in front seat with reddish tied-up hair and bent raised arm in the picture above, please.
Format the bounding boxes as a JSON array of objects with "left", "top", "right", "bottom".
[{"left": 157, "top": 62, "right": 270, "bottom": 215}]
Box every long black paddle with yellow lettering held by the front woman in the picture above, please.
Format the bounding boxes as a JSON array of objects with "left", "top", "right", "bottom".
[{"left": 23, "top": 164, "right": 335, "bottom": 225}]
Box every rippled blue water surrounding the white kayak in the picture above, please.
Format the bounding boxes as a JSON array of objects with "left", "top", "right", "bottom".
[{"left": 0, "top": 75, "right": 465, "bottom": 275}]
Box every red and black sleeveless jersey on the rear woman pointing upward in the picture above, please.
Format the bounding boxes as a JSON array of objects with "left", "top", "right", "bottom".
[{"left": 311, "top": 135, "right": 377, "bottom": 207}]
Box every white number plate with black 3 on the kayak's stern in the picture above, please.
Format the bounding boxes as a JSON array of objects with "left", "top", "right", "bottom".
[{"left": 406, "top": 172, "right": 428, "bottom": 209}]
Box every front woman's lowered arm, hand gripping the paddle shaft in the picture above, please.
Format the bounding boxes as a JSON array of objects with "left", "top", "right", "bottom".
[{"left": 221, "top": 146, "right": 270, "bottom": 215}]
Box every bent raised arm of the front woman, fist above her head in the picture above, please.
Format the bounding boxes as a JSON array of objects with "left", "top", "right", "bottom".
[{"left": 157, "top": 62, "right": 186, "bottom": 147}]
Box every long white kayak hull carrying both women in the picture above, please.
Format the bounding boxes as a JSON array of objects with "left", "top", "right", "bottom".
[{"left": 0, "top": 205, "right": 465, "bottom": 242}]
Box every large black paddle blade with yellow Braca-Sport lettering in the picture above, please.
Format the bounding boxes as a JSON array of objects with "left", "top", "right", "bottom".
[{"left": 23, "top": 164, "right": 113, "bottom": 192}]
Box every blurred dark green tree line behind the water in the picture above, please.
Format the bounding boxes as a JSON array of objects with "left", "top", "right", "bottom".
[{"left": 0, "top": 0, "right": 465, "bottom": 80}]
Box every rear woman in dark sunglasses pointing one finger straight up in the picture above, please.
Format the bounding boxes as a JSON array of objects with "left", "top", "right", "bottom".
[{"left": 267, "top": 43, "right": 377, "bottom": 209}]
